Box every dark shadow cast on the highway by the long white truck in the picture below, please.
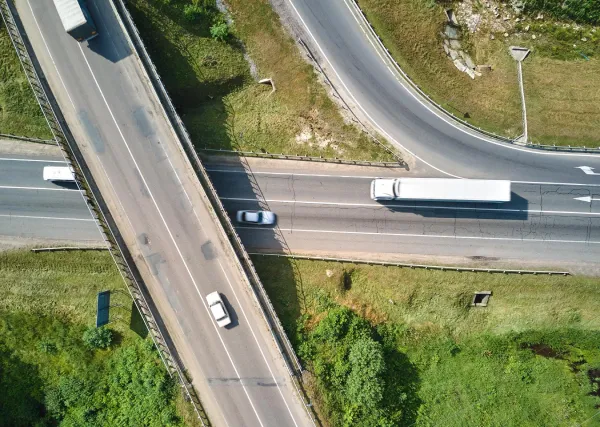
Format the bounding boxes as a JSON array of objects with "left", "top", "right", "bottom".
[{"left": 379, "top": 193, "right": 530, "bottom": 221}]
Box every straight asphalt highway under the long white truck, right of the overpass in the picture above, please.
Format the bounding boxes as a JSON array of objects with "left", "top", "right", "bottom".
[{"left": 209, "top": 165, "right": 600, "bottom": 263}]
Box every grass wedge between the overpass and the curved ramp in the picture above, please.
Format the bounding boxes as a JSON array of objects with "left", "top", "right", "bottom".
[{"left": 128, "top": 0, "right": 391, "bottom": 160}]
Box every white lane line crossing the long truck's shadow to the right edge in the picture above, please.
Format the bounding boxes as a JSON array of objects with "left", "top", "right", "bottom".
[{"left": 219, "top": 196, "right": 600, "bottom": 216}]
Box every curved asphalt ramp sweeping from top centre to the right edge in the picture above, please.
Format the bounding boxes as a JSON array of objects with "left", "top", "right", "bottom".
[{"left": 287, "top": 0, "right": 600, "bottom": 184}]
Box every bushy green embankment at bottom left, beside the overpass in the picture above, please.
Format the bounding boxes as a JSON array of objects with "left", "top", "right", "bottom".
[{"left": 0, "top": 251, "right": 200, "bottom": 426}]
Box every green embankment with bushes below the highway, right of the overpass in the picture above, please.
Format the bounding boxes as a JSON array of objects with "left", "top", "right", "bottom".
[{"left": 254, "top": 256, "right": 600, "bottom": 427}]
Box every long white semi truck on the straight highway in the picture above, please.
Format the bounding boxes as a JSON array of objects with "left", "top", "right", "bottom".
[{"left": 371, "top": 178, "right": 510, "bottom": 203}]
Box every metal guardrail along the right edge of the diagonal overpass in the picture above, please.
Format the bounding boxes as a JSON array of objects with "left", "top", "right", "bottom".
[{"left": 111, "top": 0, "right": 316, "bottom": 423}]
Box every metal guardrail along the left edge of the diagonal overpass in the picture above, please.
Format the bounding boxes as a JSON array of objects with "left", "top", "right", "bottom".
[{"left": 0, "top": 4, "right": 210, "bottom": 426}]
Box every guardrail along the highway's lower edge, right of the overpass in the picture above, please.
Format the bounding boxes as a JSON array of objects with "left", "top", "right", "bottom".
[{"left": 250, "top": 252, "right": 571, "bottom": 276}]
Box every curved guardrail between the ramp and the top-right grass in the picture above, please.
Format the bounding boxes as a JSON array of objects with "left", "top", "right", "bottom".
[{"left": 340, "top": 0, "right": 600, "bottom": 154}]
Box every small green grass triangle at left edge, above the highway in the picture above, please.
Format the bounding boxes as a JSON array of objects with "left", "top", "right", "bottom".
[{"left": 0, "top": 20, "right": 52, "bottom": 138}]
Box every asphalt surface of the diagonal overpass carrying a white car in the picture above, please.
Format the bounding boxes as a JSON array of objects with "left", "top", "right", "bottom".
[{"left": 16, "top": 0, "right": 311, "bottom": 426}]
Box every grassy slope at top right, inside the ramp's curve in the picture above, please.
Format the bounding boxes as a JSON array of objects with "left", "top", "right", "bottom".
[{"left": 358, "top": 0, "right": 600, "bottom": 147}]
